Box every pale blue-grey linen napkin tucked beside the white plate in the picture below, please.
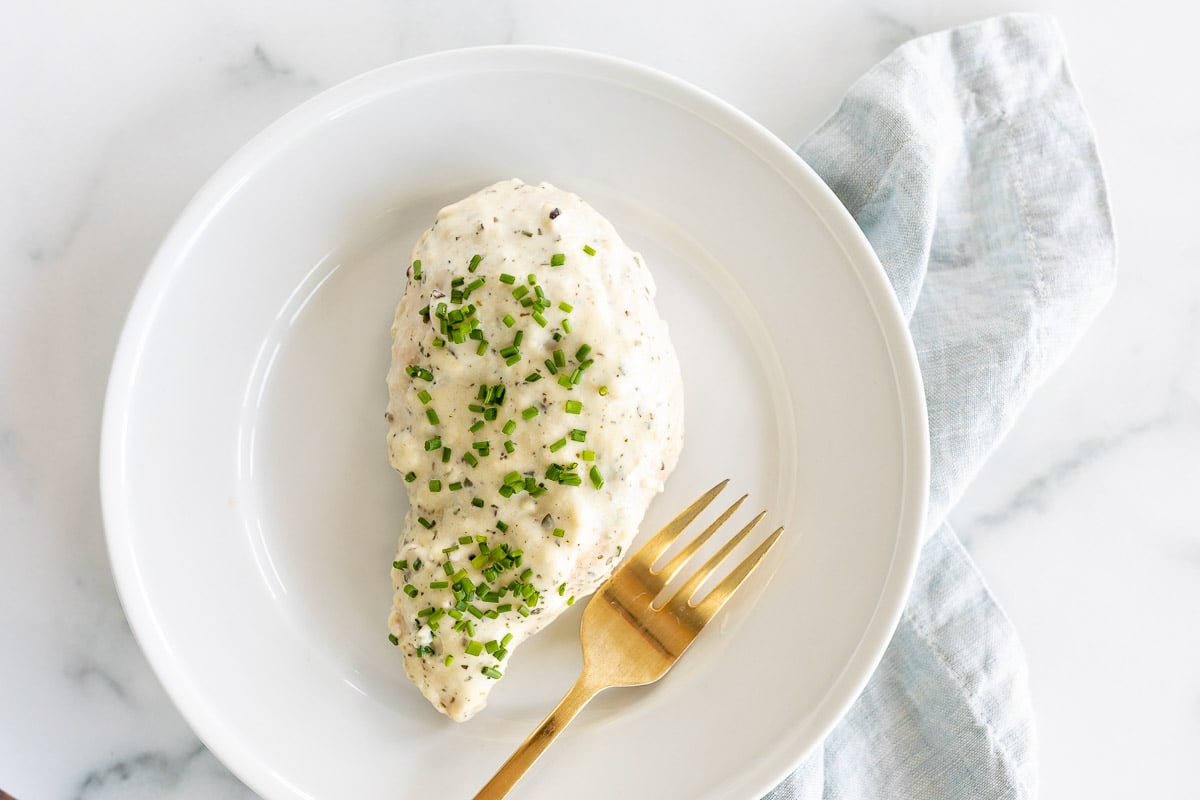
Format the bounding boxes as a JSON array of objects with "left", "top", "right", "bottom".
[{"left": 768, "top": 14, "right": 1115, "bottom": 800}]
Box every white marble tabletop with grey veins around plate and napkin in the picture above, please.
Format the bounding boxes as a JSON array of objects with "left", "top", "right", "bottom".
[{"left": 0, "top": 0, "right": 1200, "bottom": 800}]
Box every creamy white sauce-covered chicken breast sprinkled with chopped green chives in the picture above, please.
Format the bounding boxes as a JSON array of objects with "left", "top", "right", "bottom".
[{"left": 386, "top": 180, "right": 683, "bottom": 721}]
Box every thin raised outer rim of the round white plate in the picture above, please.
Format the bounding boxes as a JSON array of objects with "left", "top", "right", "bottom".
[{"left": 100, "top": 44, "right": 930, "bottom": 798}]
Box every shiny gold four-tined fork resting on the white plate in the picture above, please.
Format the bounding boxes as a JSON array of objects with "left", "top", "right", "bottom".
[{"left": 475, "top": 479, "right": 784, "bottom": 800}]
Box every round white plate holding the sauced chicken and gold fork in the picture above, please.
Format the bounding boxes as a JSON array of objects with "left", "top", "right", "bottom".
[{"left": 102, "top": 48, "right": 928, "bottom": 800}]
